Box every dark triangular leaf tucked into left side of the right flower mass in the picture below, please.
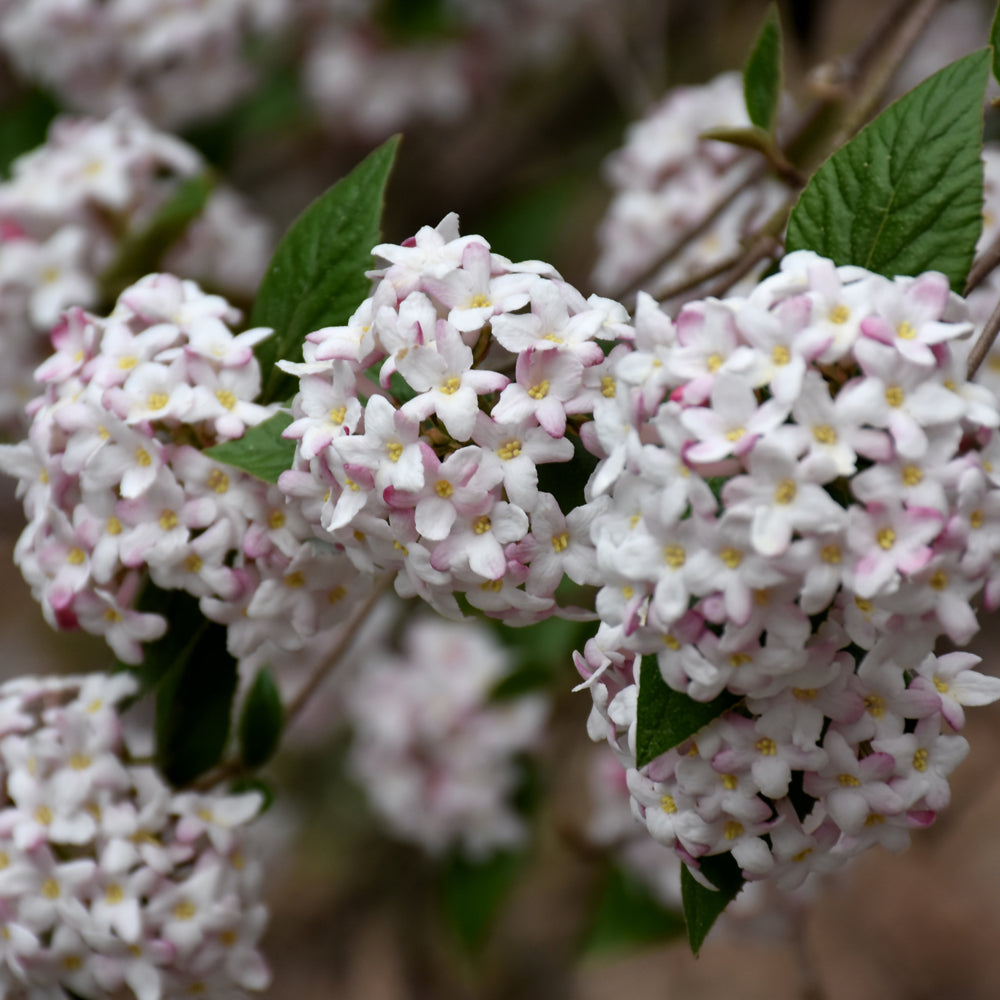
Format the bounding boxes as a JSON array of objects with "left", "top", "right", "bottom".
[{"left": 635, "top": 656, "right": 742, "bottom": 767}]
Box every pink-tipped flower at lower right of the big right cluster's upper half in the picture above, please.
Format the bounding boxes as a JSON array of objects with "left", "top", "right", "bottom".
[{"left": 846, "top": 499, "right": 943, "bottom": 598}]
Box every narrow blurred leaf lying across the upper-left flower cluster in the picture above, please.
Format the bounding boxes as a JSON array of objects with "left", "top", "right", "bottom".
[{"left": 100, "top": 170, "right": 215, "bottom": 302}]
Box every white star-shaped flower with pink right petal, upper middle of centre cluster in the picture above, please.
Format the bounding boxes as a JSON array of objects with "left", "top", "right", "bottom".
[{"left": 398, "top": 321, "right": 509, "bottom": 441}]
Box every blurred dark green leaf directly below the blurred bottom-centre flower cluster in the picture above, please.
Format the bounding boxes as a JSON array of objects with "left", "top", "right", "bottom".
[{"left": 441, "top": 851, "right": 524, "bottom": 954}]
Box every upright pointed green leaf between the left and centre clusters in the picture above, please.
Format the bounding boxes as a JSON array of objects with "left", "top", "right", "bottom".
[{"left": 250, "top": 136, "right": 399, "bottom": 403}]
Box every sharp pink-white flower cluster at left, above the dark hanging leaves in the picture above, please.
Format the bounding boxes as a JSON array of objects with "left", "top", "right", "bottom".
[{"left": 0, "top": 275, "right": 365, "bottom": 663}]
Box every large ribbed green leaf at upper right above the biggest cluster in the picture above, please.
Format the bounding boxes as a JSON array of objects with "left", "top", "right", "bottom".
[{"left": 786, "top": 49, "right": 990, "bottom": 291}]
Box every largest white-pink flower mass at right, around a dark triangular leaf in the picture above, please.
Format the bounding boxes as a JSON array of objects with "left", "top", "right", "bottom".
[{"left": 577, "top": 252, "right": 1000, "bottom": 886}]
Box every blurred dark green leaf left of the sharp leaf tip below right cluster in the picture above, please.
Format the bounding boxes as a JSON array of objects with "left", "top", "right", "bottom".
[{"left": 583, "top": 868, "right": 684, "bottom": 954}]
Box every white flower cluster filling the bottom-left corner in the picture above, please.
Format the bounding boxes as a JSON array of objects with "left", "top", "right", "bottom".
[{"left": 0, "top": 674, "right": 270, "bottom": 1000}]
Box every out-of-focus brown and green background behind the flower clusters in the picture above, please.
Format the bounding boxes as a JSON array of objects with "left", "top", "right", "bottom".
[{"left": 0, "top": 0, "right": 1000, "bottom": 1000}]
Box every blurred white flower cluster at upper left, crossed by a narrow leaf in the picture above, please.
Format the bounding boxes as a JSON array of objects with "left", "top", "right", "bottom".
[{"left": 0, "top": 111, "right": 271, "bottom": 424}]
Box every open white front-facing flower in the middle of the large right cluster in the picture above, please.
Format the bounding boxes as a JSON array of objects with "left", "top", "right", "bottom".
[{"left": 722, "top": 441, "right": 845, "bottom": 556}]
